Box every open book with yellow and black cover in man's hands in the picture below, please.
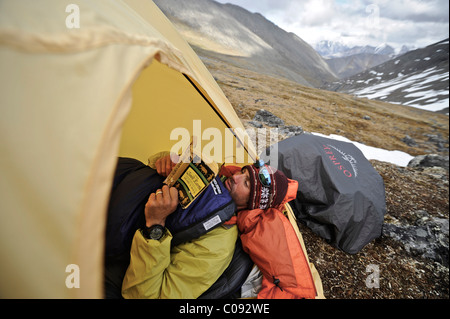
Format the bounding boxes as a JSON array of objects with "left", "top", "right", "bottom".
[{"left": 164, "top": 143, "right": 219, "bottom": 209}]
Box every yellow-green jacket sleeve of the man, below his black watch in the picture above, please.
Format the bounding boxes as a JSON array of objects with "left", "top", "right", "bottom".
[{"left": 122, "top": 226, "right": 238, "bottom": 299}]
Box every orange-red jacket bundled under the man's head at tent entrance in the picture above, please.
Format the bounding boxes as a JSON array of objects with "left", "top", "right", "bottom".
[{"left": 221, "top": 169, "right": 316, "bottom": 299}]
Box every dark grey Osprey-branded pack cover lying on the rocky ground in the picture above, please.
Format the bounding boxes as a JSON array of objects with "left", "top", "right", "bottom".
[{"left": 261, "top": 134, "right": 386, "bottom": 254}]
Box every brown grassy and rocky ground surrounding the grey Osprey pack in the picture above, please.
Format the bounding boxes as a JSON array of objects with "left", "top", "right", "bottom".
[{"left": 201, "top": 54, "right": 449, "bottom": 299}]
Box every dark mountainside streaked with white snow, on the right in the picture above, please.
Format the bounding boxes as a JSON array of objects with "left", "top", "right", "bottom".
[{"left": 323, "top": 39, "right": 449, "bottom": 114}]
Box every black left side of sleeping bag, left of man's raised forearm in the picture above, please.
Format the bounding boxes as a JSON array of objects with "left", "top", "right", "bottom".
[{"left": 104, "top": 158, "right": 164, "bottom": 299}]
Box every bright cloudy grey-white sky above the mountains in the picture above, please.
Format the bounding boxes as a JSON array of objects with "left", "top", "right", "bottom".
[{"left": 216, "top": 0, "right": 449, "bottom": 49}]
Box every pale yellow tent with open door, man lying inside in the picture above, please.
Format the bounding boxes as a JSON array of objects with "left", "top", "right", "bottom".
[{"left": 0, "top": 0, "right": 256, "bottom": 298}]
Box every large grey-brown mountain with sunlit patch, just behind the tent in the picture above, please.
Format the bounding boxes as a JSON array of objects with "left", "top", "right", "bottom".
[{"left": 154, "top": 0, "right": 337, "bottom": 87}]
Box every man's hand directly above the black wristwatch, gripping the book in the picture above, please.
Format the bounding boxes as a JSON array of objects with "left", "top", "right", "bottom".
[{"left": 145, "top": 185, "right": 178, "bottom": 227}]
